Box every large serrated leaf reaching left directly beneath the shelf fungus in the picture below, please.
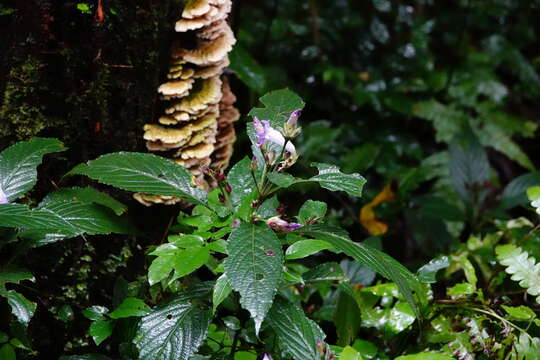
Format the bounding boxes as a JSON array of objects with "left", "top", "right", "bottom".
[{"left": 68, "top": 152, "right": 206, "bottom": 205}]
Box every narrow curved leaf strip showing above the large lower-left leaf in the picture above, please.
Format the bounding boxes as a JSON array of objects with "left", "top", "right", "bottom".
[{"left": 40, "top": 187, "right": 127, "bottom": 215}]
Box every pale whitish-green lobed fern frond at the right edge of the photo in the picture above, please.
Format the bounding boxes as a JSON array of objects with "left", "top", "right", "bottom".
[{"left": 495, "top": 245, "right": 540, "bottom": 304}]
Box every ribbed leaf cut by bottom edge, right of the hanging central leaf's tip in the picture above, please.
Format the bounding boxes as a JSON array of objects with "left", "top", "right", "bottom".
[{"left": 266, "top": 297, "right": 326, "bottom": 360}]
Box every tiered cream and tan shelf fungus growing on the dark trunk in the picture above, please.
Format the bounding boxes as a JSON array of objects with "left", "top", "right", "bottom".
[{"left": 135, "top": 0, "right": 240, "bottom": 205}]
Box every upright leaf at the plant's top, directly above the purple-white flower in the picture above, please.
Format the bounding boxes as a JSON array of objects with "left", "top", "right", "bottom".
[{"left": 248, "top": 89, "right": 305, "bottom": 128}]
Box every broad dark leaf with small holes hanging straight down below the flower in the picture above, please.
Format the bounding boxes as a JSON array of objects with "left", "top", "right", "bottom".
[{"left": 224, "top": 223, "right": 283, "bottom": 333}]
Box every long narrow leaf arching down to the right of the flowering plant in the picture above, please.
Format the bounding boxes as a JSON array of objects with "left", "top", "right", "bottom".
[{"left": 298, "top": 225, "right": 423, "bottom": 318}]
